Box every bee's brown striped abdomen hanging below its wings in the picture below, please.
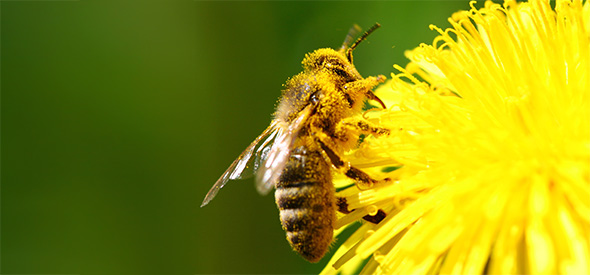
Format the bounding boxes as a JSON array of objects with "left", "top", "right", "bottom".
[{"left": 275, "top": 146, "right": 336, "bottom": 262}]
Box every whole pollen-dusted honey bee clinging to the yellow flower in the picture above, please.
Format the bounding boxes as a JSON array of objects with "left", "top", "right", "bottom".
[{"left": 201, "top": 23, "right": 390, "bottom": 262}]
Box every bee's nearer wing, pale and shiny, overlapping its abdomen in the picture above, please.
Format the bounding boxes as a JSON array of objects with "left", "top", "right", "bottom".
[{"left": 256, "top": 104, "right": 316, "bottom": 195}]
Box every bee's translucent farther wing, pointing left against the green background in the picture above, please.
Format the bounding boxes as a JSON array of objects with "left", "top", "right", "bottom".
[{"left": 201, "top": 121, "right": 278, "bottom": 207}]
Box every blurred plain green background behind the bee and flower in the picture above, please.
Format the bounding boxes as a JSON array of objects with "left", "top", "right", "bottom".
[{"left": 0, "top": 0, "right": 468, "bottom": 274}]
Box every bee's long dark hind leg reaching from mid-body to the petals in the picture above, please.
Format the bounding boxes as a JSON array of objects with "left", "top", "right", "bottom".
[{"left": 316, "top": 138, "right": 391, "bottom": 189}]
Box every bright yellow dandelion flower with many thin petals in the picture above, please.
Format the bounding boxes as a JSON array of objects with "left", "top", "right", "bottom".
[{"left": 322, "top": 0, "right": 590, "bottom": 274}]
